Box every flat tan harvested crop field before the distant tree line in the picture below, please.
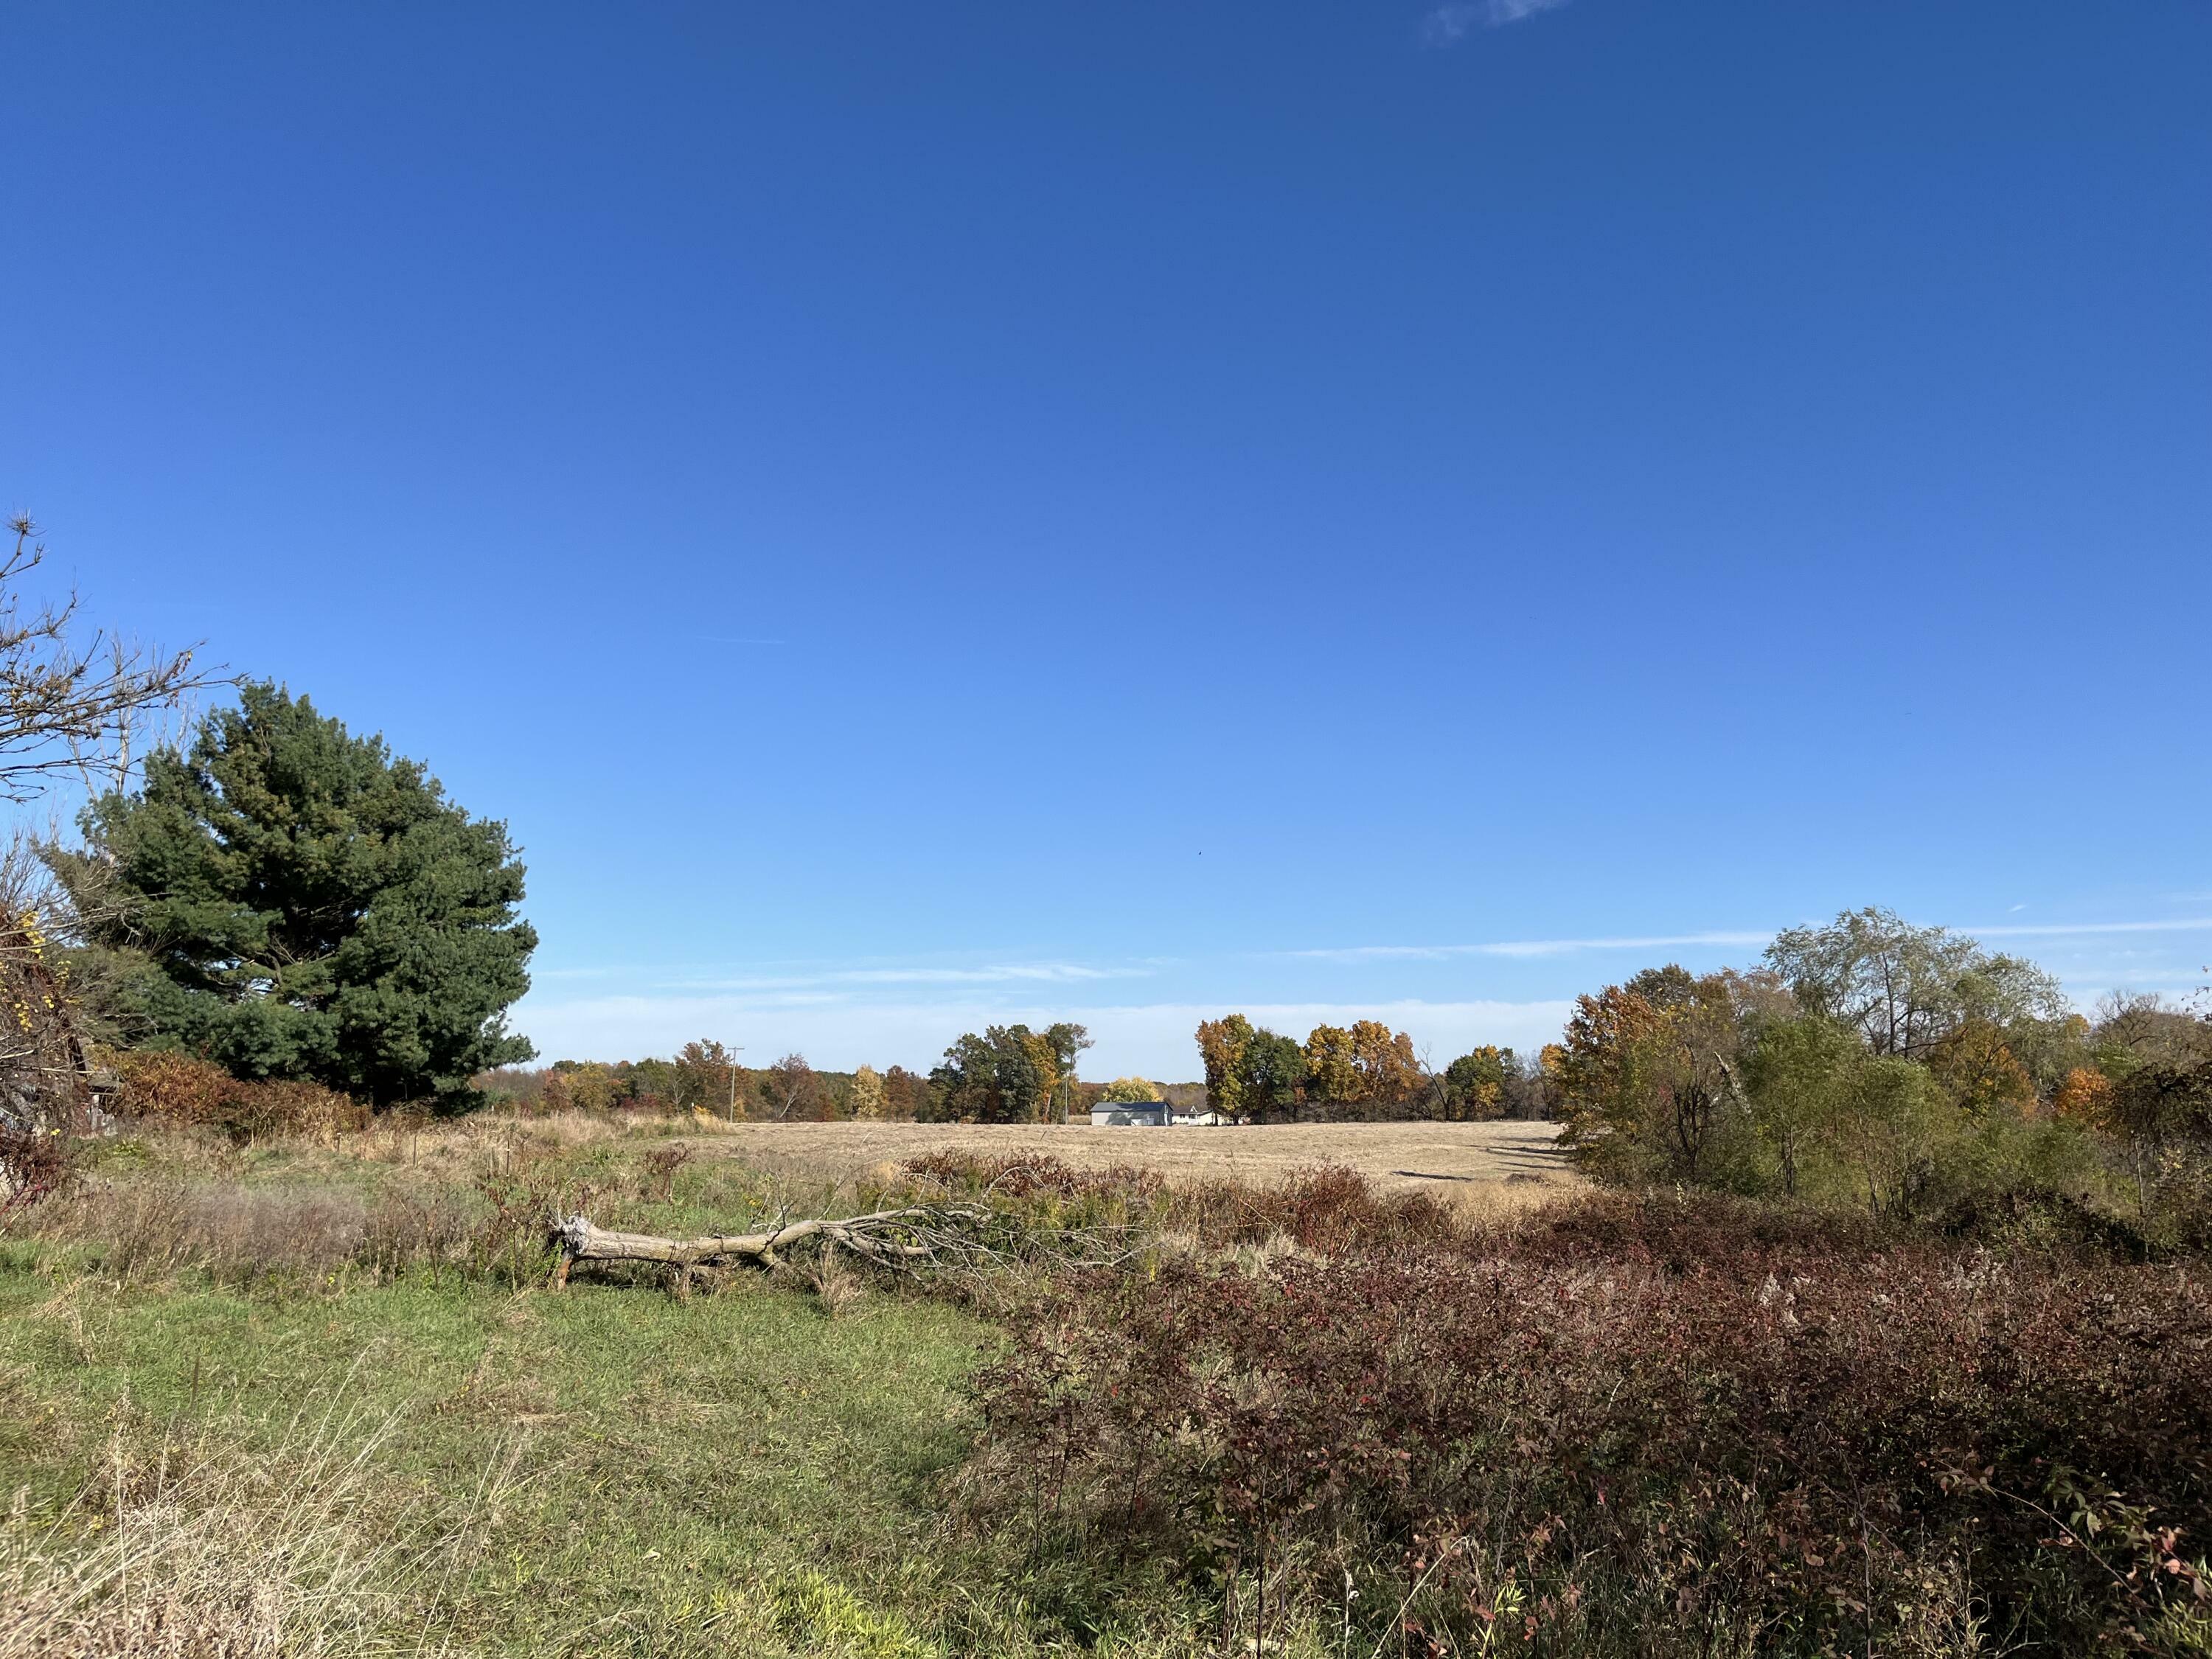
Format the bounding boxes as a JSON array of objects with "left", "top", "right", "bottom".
[{"left": 681, "top": 1121, "right": 1577, "bottom": 1201}]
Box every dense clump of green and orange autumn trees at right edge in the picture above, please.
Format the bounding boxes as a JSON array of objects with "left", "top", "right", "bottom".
[{"left": 1548, "top": 909, "right": 2212, "bottom": 1250}]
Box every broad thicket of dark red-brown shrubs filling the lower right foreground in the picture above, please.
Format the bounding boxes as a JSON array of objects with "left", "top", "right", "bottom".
[{"left": 967, "top": 1199, "right": 2212, "bottom": 1652}]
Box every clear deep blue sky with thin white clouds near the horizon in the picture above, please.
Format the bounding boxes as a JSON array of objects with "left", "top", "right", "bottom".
[{"left": 0, "top": 0, "right": 2212, "bottom": 1077}]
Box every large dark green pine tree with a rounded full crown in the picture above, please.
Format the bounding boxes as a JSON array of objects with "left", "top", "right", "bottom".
[{"left": 58, "top": 684, "right": 538, "bottom": 1106}]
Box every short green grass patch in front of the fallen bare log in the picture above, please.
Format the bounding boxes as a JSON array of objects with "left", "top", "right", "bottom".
[{"left": 0, "top": 1245, "right": 989, "bottom": 1655}]
